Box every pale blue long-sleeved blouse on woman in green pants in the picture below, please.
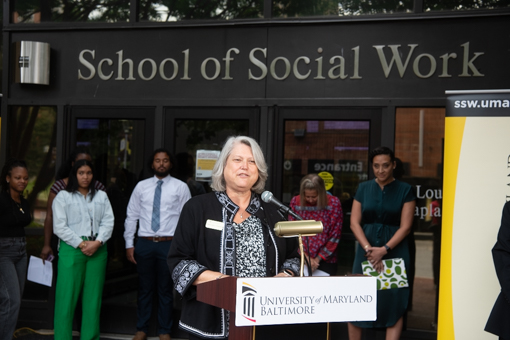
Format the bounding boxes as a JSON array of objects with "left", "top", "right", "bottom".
[{"left": 52, "top": 190, "right": 114, "bottom": 248}]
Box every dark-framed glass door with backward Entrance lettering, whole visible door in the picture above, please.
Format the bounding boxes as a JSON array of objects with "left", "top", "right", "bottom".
[{"left": 275, "top": 108, "right": 381, "bottom": 275}]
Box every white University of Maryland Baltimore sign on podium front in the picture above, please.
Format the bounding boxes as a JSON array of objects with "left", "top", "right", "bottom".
[{"left": 235, "top": 276, "right": 377, "bottom": 326}]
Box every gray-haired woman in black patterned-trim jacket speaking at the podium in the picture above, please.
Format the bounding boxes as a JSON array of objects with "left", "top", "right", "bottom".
[{"left": 168, "top": 136, "right": 299, "bottom": 340}]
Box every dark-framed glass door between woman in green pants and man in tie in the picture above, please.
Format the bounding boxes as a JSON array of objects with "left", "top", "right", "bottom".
[{"left": 68, "top": 107, "right": 155, "bottom": 334}]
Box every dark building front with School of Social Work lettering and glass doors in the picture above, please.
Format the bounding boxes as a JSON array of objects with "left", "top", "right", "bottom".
[{"left": 0, "top": 0, "right": 510, "bottom": 338}]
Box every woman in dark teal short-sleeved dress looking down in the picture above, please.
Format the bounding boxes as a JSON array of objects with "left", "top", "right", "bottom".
[{"left": 348, "top": 147, "right": 416, "bottom": 340}]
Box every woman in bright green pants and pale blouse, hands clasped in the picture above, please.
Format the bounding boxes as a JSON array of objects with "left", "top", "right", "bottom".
[{"left": 53, "top": 160, "right": 114, "bottom": 340}]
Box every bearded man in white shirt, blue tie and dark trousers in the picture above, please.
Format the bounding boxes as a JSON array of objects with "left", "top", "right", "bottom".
[{"left": 124, "top": 149, "right": 191, "bottom": 340}]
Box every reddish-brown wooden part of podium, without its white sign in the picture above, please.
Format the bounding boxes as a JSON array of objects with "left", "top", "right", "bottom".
[{"left": 197, "top": 276, "right": 254, "bottom": 340}]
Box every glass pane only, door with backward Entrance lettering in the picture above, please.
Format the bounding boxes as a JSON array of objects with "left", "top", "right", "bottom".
[{"left": 282, "top": 120, "right": 370, "bottom": 275}]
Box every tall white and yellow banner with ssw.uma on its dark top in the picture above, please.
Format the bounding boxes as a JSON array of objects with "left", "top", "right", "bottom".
[{"left": 438, "top": 90, "right": 510, "bottom": 340}]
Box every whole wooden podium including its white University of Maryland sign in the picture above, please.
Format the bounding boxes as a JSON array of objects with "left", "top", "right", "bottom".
[{"left": 197, "top": 276, "right": 377, "bottom": 340}]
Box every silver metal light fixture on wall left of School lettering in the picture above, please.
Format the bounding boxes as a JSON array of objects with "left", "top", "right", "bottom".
[{"left": 14, "top": 41, "right": 50, "bottom": 85}]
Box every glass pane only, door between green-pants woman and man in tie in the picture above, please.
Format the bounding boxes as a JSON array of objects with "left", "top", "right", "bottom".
[{"left": 75, "top": 118, "right": 145, "bottom": 278}]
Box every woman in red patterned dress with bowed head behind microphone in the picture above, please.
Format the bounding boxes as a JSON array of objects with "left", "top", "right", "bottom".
[{"left": 290, "top": 174, "right": 343, "bottom": 275}]
